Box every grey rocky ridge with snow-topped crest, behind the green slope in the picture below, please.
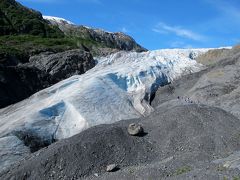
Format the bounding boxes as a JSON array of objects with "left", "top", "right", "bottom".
[{"left": 43, "top": 16, "right": 146, "bottom": 53}]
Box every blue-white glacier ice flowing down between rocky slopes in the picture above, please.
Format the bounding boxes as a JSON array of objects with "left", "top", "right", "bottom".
[{"left": 0, "top": 49, "right": 216, "bottom": 172}]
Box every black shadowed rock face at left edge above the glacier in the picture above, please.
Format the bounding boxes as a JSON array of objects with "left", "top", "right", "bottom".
[{"left": 0, "top": 65, "right": 52, "bottom": 108}]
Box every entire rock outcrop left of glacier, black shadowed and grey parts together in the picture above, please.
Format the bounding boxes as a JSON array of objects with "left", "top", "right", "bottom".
[{"left": 0, "top": 50, "right": 95, "bottom": 108}]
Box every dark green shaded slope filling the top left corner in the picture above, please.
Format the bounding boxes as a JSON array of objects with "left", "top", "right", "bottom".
[{"left": 0, "top": 0, "right": 63, "bottom": 37}]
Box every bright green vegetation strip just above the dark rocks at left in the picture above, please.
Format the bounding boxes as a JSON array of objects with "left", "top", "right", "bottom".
[{"left": 0, "top": 35, "right": 107, "bottom": 57}]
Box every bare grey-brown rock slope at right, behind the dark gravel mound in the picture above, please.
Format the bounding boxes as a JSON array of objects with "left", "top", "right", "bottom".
[{"left": 152, "top": 47, "right": 240, "bottom": 118}]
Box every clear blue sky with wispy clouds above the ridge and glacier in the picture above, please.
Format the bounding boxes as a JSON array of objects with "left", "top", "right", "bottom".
[{"left": 18, "top": 0, "right": 240, "bottom": 50}]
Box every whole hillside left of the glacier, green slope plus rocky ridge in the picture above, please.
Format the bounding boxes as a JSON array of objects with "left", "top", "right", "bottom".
[{"left": 0, "top": 0, "right": 146, "bottom": 58}]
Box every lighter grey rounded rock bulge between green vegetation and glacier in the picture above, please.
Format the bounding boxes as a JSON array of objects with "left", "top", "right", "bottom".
[{"left": 29, "top": 50, "right": 95, "bottom": 82}]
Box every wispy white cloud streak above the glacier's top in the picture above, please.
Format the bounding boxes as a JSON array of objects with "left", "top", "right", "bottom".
[{"left": 152, "top": 22, "right": 206, "bottom": 41}]
